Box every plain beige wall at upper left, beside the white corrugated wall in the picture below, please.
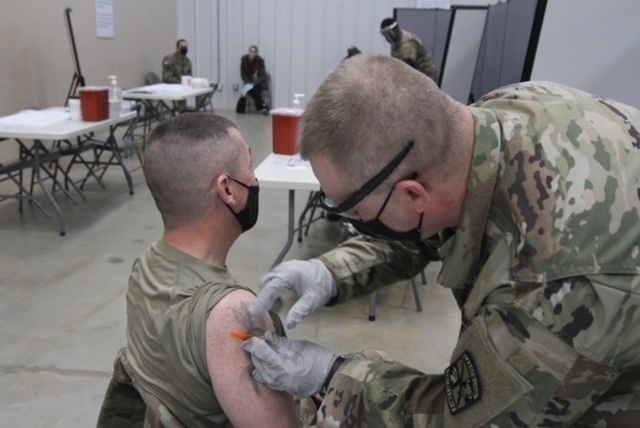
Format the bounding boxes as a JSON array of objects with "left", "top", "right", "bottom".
[{"left": 0, "top": 0, "right": 177, "bottom": 116}]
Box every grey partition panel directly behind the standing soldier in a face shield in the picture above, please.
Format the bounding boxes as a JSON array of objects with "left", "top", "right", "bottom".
[{"left": 393, "top": 8, "right": 452, "bottom": 79}]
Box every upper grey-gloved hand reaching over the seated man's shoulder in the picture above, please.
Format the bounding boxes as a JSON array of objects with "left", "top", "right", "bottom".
[{"left": 249, "top": 259, "right": 338, "bottom": 328}]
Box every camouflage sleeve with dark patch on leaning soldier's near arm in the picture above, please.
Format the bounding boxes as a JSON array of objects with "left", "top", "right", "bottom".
[{"left": 301, "top": 307, "right": 640, "bottom": 428}]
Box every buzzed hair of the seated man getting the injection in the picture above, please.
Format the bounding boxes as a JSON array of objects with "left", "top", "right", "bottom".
[{"left": 143, "top": 113, "right": 242, "bottom": 230}]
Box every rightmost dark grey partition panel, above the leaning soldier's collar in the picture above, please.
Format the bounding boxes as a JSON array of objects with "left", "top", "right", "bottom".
[{"left": 470, "top": 0, "right": 547, "bottom": 102}]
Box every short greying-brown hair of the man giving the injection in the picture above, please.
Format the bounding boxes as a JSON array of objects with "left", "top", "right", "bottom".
[{"left": 300, "top": 54, "right": 460, "bottom": 191}]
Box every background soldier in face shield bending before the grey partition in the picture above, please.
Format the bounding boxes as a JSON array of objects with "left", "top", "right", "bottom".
[{"left": 380, "top": 18, "right": 438, "bottom": 83}]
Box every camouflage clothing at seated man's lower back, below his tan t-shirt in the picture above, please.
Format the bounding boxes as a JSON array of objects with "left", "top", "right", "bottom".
[{"left": 97, "top": 348, "right": 184, "bottom": 428}]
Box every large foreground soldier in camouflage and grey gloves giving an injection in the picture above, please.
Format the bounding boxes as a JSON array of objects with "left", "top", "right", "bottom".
[{"left": 244, "top": 55, "right": 640, "bottom": 427}]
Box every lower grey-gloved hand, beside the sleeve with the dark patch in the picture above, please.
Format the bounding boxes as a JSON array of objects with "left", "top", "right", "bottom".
[{"left": 242, "top": 331, "right": 336, "bottom": 398}]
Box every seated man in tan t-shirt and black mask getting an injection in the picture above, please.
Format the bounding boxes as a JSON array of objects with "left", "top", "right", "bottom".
[{"left": 98, "top": 113, "right": 297, "bottom": 428}]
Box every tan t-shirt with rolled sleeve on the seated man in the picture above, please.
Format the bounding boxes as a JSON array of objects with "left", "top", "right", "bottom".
[{"left": 127, "top": 240, "right": 282, "bottom": 427}]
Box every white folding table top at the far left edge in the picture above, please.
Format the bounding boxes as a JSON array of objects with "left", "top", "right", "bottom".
[{"left": 0, "top": 107, "right": 136, "bottom": 140}]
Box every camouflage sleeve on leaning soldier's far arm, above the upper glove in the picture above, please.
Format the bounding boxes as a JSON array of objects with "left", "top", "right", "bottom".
[{"left": 320, "top": 235, "right": 439, "bottom": 303}]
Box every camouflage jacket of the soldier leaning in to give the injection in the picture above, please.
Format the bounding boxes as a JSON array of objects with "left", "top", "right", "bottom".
[{"left": 314, "top": 82, "right": 640, "bottom": 427}]
